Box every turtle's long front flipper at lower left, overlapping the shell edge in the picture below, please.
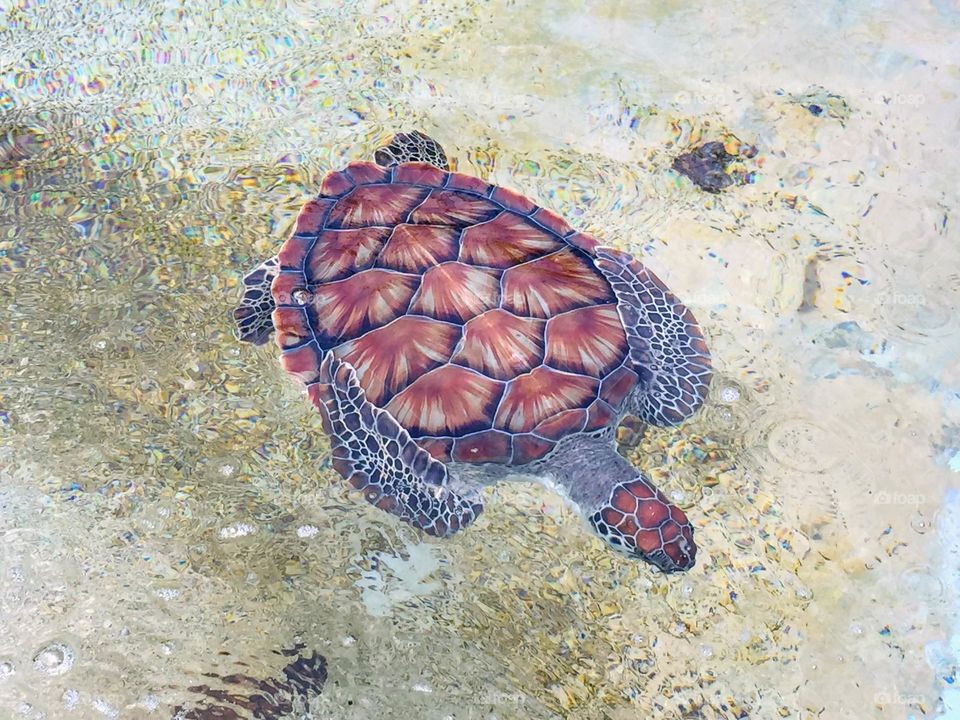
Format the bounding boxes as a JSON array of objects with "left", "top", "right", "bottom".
[{"left": 308, "top": 352, "right": 483, "bottom": 537}]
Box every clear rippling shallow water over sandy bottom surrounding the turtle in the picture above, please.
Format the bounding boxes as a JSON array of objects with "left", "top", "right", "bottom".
[{"left": 0, "top": 2, "right": 960, "bottom": 720}]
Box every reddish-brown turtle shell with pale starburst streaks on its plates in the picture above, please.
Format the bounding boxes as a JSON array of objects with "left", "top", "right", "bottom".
[{"left": 272, "top": 163, "right": 638, "bottom": 465}]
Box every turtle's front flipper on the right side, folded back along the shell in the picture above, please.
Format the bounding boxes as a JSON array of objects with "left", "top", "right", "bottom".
[{"left": 594, "top": 247, "right": 712, "bottom": 426}]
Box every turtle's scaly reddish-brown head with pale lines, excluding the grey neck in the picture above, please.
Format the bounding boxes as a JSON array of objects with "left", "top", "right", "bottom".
[{"left": 590, "top": 474, "right": 697, "bottom": 573}]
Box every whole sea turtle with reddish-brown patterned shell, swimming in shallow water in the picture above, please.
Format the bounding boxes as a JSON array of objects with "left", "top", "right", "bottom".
[{"left": 235, "top": 132, "right": 711, "bottom": 572}]
